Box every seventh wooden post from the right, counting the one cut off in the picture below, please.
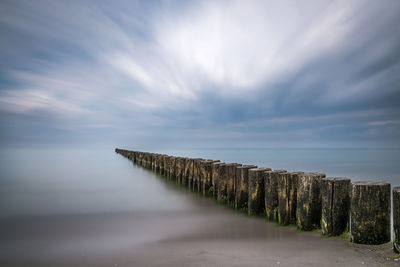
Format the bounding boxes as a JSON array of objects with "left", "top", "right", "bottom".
[{"left": 247, "top": 168, "right": 271, "bottom": 215}]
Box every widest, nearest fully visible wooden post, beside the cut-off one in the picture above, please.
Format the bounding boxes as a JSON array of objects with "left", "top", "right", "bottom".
[{"left": 350, "top": 182, "right": 390, "bottom": 245}]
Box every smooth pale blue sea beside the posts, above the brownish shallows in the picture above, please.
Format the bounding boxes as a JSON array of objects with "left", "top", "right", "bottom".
[{"left": 0, "top": 148, "right": 400, "bottom": 217}]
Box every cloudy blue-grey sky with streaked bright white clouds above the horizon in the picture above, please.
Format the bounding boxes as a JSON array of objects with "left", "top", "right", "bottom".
[{"left": 0, "top": 0, "right": 400, "bottom": 149}]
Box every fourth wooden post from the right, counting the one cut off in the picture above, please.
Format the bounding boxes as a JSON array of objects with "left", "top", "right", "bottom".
[{"left": 296, "top": 173, "right": 325, "bottom": 231}]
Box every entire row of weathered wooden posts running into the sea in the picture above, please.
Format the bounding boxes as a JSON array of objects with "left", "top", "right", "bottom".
[{"left": 115, "top": 148, "right": 400, "bottom": 252}]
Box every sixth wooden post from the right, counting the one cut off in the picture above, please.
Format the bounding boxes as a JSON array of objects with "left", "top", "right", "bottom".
[{"left": 264, "top": 170, "right": 286, "bottom": 221}]
